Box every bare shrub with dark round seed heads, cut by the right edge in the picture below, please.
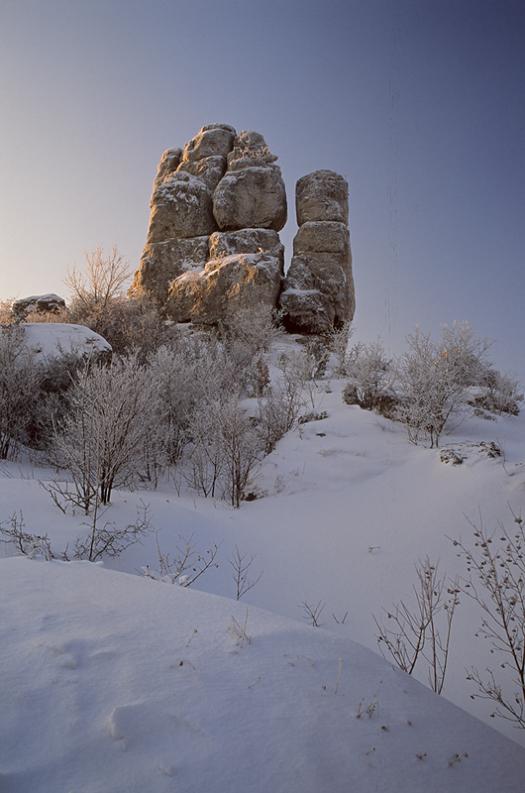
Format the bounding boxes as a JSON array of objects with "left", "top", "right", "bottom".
[{"left": 452, "top": 513, "right": 525, "bottom": 729}]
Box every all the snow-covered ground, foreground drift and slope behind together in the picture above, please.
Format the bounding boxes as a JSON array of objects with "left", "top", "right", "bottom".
[{"left": 0, "top": 342, "right": 525, "bottom": 793}]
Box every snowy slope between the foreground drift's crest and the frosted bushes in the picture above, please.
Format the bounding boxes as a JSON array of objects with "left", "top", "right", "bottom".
[{"left": 0, "top": 381, "right": 525, "bottom": 742}]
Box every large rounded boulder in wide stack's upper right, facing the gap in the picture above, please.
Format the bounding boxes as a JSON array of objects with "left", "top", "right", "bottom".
[{"left": 213, "top": 165, "right": 287, "bottom": 231}]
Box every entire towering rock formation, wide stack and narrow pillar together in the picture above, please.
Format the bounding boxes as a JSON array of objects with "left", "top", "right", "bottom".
[{"left": 131, "top": 124, "right": 354, "bottom": 333}]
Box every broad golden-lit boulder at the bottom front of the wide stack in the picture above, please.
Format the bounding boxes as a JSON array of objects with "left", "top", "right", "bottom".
[{"left": 167, "top": 253, "right": 282, "bottom": 325}]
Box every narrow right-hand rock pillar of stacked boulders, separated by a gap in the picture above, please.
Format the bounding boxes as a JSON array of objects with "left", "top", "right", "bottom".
[{"left": 280, "top": 171, "right": 355, "bottom": 334}]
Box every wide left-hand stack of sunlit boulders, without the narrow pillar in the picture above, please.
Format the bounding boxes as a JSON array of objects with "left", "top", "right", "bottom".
[{"left": 132, "top": 124, "right": 286, "bottom": 324}]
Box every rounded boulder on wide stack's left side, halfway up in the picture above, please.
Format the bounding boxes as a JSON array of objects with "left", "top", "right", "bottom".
[{"left": 147, "top": 171, "right": 217, "bottom": 244}]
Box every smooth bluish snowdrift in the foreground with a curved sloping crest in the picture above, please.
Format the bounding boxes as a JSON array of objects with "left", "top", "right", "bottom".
[{"left": 0, "top": 558, "right": 525, "bottom": 793}]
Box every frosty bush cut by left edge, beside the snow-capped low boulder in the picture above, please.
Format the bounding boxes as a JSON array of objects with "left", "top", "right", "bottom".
[{"left": 0, "top": 325, "right": 42, "bottom": 460}]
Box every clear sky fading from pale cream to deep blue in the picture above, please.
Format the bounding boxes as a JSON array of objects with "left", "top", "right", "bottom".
[{"left": 0, "top": 0, "right": 525, "bottom": 374}]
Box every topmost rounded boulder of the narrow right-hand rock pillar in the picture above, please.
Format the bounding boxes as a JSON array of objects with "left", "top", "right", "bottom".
[{"left": 295, "top": 171, "right": 348, "bottom": 226}]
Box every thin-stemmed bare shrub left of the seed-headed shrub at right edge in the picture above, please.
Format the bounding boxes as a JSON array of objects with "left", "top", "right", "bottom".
[{"left": 374, "top": 557, "right": 459, "bottom": 694}]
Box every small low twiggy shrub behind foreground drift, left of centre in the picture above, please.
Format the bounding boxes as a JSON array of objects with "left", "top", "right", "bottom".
[{"left": 142, "top": 534, "right": 219, "bottom": 587}]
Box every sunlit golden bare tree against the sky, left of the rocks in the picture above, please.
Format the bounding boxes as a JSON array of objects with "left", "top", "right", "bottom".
[{"left": 66, "top": 245, "right": 131, "bottom": 311}]
